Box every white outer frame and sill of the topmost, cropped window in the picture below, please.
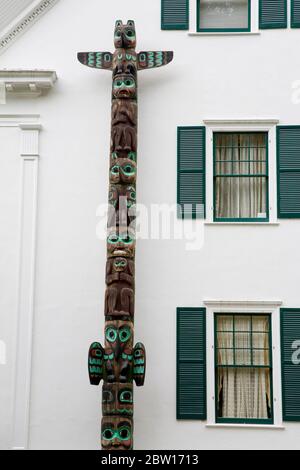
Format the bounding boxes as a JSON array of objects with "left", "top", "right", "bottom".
[{"left": 188, "top": 0, "right": 260, "bottom": 36}]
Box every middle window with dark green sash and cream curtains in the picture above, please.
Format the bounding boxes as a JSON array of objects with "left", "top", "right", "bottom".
[{"left": 214, "top": 132, "right": 269, "bottom": 222}]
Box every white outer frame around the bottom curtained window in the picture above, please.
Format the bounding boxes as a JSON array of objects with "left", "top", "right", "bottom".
[{"left": 204, "top": 300, "right": 285, "bottom": 429}]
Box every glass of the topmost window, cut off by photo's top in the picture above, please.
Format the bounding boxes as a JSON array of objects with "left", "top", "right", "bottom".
[{"left": 198, "top": 0, "right": 249, "bottom": 29}]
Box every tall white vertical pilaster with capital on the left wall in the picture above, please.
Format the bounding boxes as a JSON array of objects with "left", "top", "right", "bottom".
[{"left": 5, "top": 115, "right": 41, "bottom": 450}]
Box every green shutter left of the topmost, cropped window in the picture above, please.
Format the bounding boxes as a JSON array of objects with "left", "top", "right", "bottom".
[{"left": 161, "top": 0, "right": 189, "bottom": 29}]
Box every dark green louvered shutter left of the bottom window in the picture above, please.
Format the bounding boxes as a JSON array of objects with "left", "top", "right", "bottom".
[{"left": 177, "top": 308, "right": 206, "bottom": 420}]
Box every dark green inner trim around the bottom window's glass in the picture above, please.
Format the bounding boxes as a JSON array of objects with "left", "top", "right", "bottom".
[{"left": 214, "top": 312, "right": 274, "bottom": 425}]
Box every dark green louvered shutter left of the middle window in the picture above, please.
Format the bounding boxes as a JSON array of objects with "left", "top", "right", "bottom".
[{"left": 177, "top": 127, "right": 205, "bottom": 219}]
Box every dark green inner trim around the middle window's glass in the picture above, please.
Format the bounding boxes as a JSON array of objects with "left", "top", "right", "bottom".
[{"left": 213, "top": 131, "right": 270, "bottom": 224}]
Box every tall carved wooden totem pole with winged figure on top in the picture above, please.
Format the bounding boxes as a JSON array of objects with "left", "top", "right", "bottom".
[{"left": 78, "top": 21, "right": 173, "bottom": 450}]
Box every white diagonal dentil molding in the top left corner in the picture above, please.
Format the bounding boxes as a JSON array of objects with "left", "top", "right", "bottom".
[{"left": 0, "top": 0, "right": 58, "bottom": 54}]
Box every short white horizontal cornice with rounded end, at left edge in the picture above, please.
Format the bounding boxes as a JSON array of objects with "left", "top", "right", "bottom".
[{"left": 0, "top": 70, "right": 57, "bottom": 99}]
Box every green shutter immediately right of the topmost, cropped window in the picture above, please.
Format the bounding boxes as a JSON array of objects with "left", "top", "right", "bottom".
[{"left": 259, "top": 0, "right": 287, "bottom": 29}]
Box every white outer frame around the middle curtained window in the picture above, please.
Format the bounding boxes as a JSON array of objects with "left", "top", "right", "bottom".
[{"left": 203, "top": 119, "right": 279, "bottom": 225}]
